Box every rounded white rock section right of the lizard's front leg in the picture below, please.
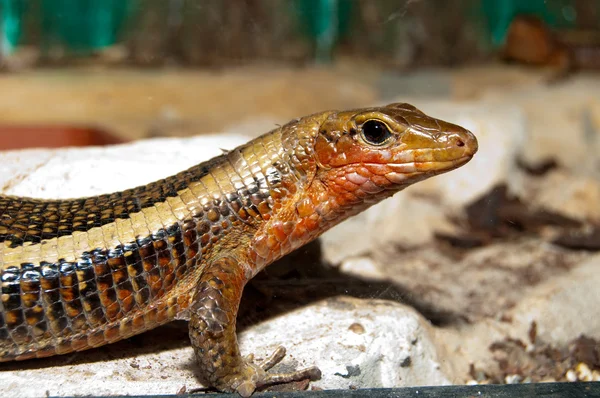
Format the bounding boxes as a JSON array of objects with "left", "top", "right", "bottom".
[{"left": 241, "top": 297, "right": 449, "bottom": 389}]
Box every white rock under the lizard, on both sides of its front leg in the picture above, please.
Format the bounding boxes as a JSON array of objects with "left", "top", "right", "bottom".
[{"left": 0, "top": 298, "right": 449, "bottom": 397}]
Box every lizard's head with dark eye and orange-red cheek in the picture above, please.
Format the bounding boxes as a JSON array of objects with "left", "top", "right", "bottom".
[{"left": 314, "top": 104, "right": 477, "bottom": 205}]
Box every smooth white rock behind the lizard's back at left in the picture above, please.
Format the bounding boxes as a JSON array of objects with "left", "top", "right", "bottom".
[{"left": 0, "top": 135, "right": 248, "bottom": 199}]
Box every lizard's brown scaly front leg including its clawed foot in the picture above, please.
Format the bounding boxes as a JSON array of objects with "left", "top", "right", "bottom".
[{"left": 189, "top": 257, "right": 321, "bottom": 397}]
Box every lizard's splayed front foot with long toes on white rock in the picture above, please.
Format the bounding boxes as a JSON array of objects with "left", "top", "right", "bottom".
[{"left": 231, "top": 346, "right": 321, "bottom": 398}]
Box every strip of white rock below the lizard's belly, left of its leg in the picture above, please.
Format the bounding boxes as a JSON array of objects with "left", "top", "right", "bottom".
[{"left": 0, "top": 327, "right": 200, "bottom": 397}]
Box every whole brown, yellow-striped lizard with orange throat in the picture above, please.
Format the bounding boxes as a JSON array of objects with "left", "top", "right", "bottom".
[{"left": 0, "top": 104, "right": 477, "bottom": 397}]
